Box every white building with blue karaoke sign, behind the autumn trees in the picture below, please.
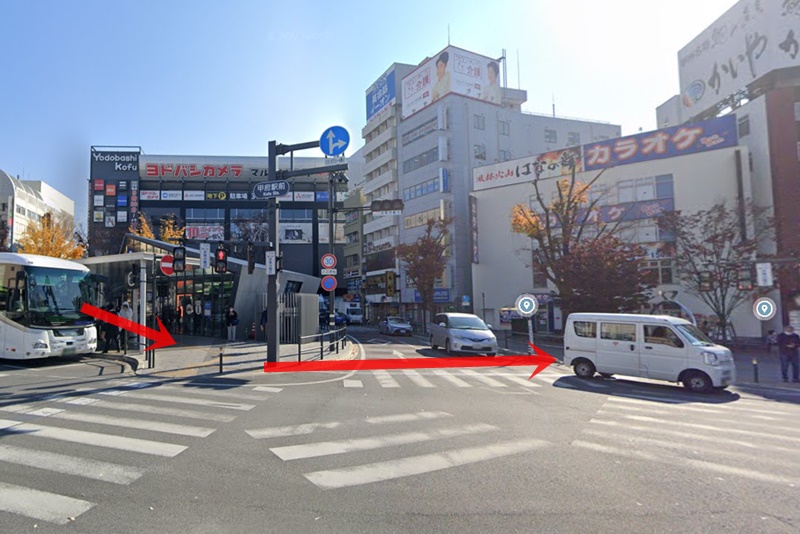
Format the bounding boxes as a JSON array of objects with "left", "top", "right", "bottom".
[{"left": 473, "top": 116, "right": 762, "bottom": 337}]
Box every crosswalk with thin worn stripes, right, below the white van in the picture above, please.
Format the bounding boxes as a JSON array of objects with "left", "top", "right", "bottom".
[{"left": 571, "top": 394, "right": 800, "bottom": 487}]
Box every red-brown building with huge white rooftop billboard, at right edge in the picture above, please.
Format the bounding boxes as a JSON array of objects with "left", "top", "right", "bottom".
[{"left": 656, "top": 0, "right": 800, "bottom": 330}]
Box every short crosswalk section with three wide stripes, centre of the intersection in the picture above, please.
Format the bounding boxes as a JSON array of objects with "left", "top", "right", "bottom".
[{"left": 247, "top": 411, "right": 552, "bottom": 489}]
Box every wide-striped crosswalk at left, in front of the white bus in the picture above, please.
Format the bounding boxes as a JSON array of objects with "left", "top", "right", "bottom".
[{"left": 0, "top": 380, "right": 282, "bottom": 524}]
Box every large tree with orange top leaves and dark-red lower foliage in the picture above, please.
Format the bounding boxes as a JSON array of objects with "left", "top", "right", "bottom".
[{"left": 511, "top": 161, "right": 651, "bottom": 317}]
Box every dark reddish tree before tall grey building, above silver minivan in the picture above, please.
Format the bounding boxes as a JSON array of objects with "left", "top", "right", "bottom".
[{"left": 395, "top": 218, "right": 452, "bottom": 330}]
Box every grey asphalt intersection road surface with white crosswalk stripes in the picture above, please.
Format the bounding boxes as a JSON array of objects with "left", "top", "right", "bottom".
[{"left": 0, "top": 329, "right": 800, "bottom": 533}]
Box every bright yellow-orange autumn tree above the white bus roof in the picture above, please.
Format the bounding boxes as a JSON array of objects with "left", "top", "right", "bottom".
[{"left": 19, "top": 213, "right": 86, "bottom": 259}]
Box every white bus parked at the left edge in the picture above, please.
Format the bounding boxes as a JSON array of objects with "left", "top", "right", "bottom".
[{"left": 0, "top": 252, "right": 97, "bottom": 360}]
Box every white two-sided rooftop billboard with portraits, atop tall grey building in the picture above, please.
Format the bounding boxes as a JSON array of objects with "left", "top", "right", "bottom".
[{"left": 402, "top": 46, "right": 502, "bottom": 119}]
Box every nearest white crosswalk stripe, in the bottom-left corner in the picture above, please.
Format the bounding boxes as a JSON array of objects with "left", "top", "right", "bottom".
[{"left": 0, "top": 482, "right": 94, "bottom": 525}]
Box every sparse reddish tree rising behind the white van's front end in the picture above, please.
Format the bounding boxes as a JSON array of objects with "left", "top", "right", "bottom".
[{"left": 659, "top": 201, "right": 775, "bottom": 343}]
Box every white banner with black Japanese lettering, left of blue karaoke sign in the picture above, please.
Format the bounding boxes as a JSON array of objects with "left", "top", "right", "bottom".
[{"left": 472, "top": 147, "right": 583, "bottom": 191}]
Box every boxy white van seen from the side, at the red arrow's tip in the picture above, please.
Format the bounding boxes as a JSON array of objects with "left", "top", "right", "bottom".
[{"left": 564, "top": 313, "right": 736, "bottom": 392}]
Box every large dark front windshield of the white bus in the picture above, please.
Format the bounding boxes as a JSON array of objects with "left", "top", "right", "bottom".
[{"left": 24, "top": 267, "right": 94, "bottom": 327}]
